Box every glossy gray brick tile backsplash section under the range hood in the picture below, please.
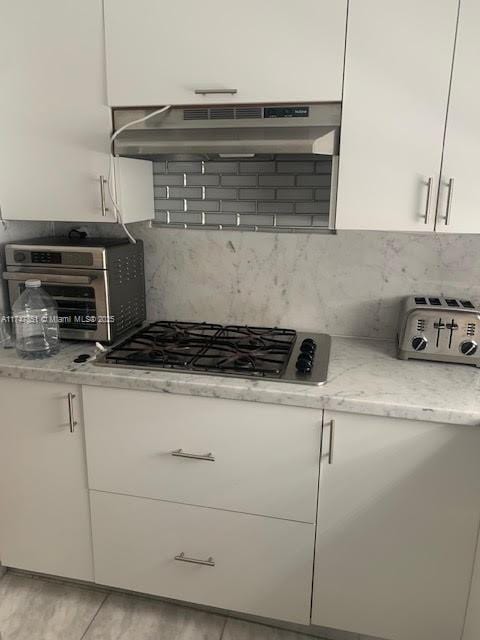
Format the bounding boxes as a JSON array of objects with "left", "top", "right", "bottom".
[{"left": 153, "top": 155, "right": 332, "bottom": 226}]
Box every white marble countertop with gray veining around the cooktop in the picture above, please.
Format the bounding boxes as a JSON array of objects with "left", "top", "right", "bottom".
[{"left": 0, "top": 337, "right": 480, "bottom": 425}]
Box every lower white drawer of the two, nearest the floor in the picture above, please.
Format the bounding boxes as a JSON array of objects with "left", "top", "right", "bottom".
[{"left": 91, "top": 491, "right": 314, "bottom": 624}]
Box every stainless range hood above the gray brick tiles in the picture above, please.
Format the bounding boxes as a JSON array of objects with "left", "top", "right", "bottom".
[{"left": 113, "top": 102, "right": 341, "bottom": 158}]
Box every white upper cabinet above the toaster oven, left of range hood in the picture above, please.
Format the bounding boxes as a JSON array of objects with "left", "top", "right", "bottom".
[{"left": 0, "top": 0, "right": 153, "bottom": 222}]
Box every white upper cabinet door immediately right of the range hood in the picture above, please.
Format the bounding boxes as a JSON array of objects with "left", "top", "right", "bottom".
[{"left": 336, "top": 0, "right": 458, "bottom": 231}]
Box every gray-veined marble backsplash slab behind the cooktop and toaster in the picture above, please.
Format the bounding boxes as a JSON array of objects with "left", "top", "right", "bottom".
[{"left": 5, "top": 223, "right": 480, "bottom": 338}]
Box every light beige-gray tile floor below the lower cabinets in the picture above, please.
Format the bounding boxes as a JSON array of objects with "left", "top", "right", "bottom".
[{"left": 0, "top": 572, "right": 370, "bottom": 640}]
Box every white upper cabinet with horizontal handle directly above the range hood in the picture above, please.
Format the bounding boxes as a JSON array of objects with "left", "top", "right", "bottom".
[{"left": 105, "top": 0, "right": 346, "bottom": 106}]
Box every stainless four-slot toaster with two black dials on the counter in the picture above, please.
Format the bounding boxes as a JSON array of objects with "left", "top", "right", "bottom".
[{"left": 397, "top": 295, "right": 480, "bottom": 367}]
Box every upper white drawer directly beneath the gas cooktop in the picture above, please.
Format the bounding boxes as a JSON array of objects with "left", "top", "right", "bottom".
[{"left": 84, "top": 387, "right": 322, "bottom": 522}]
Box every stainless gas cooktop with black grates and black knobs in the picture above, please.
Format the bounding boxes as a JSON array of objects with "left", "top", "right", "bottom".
[{"left": 96, "top": 321, "right": 330, "bottom": 385}]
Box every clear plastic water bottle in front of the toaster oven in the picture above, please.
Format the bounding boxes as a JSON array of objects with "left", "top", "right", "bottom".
[{"left": 12, "top": 280, "right": 60, "bottom": 359}]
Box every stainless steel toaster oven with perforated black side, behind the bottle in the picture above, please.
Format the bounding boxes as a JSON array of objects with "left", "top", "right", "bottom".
[{"left": 3, "top": 238, "right": 145, "bottom": 342}]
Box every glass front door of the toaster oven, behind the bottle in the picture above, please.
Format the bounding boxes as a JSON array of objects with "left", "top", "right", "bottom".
[{"left": 3, "top": 267, "right": 113, "bottom": 341}]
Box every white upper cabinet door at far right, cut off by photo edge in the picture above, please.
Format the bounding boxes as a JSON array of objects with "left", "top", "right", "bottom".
[{"left": 436, "top": 0, "right": 480, "bottom": 233}]
